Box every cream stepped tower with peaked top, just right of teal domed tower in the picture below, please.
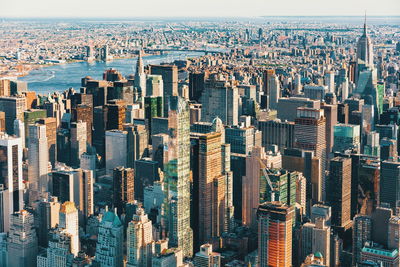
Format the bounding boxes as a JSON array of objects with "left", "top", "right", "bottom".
[{"left": 127, "top": 208, "right": 154, "bottom": 267}]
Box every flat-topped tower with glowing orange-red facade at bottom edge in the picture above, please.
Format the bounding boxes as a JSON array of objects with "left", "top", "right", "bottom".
[{"left": 257, "top": 202, "right": 294, "bottom": 267}]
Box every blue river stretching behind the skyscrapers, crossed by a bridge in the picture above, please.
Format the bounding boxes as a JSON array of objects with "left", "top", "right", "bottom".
[{"left": 19, "top": 51, "right": 204, "bottom": 94}]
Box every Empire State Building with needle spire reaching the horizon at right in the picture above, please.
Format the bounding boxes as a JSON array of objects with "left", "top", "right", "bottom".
[{"left": 357, "top": 14, "right": 374, "bottom": 70}]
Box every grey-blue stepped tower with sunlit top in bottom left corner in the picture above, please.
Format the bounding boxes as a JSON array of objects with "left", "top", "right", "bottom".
[{"left": 7, "top": 210, "right": 38, "bottom": 267}]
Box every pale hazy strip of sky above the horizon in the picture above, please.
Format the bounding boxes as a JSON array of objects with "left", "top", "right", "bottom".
[{"left": 0, "top": 0, "right": 400, "bottom": 18}]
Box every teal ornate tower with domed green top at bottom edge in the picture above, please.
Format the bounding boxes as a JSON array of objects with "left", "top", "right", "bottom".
[{"left": 95, "top": 211, "right": 124, "bottom": 267}]
